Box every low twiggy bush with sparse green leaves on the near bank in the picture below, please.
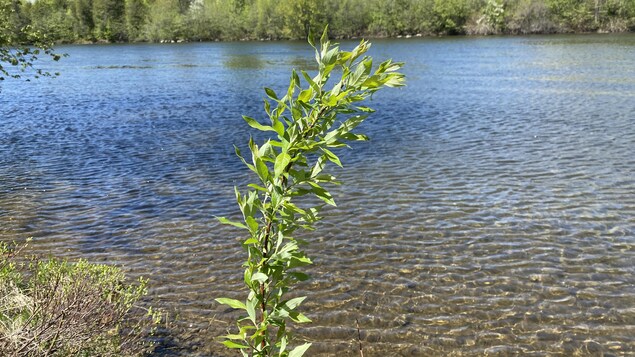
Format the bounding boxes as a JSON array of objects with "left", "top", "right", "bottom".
[{"left": 0, "top": 242, "right": 161, "bottom": 357}]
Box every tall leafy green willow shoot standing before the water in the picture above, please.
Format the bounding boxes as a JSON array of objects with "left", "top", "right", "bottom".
[{"left": 216, "top": 30, "right": 404, "bottom": 357}]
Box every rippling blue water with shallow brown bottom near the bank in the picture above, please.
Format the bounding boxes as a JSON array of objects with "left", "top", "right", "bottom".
[{"left": 0, "top": 35, "right": 635, "bottom": 356}]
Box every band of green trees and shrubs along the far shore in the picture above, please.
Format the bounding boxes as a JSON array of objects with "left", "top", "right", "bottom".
[{"left": 0, "top": 0, "right": 635, "bottom": 42}]
